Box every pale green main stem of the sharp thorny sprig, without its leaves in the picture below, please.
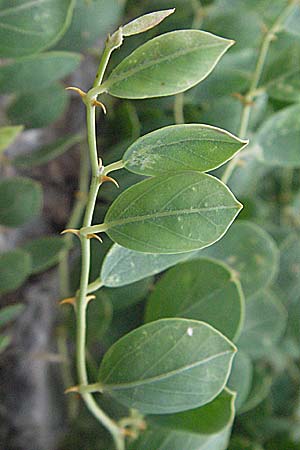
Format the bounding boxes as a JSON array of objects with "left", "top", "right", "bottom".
[{"left": 76, "top": 41, "right": 125, "bottom": 450}]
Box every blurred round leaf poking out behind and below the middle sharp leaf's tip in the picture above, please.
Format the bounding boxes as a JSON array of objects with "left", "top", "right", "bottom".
[{"left": 201, "top": 220, "right": 279, "bottom": 297}]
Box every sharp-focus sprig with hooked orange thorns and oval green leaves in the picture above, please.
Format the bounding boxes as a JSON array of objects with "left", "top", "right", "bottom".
[{"left": 60, "top": 10, "right": 247, "bottom": 450}]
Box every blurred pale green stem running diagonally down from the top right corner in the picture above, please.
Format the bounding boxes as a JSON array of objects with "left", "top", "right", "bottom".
[{"left": 222, "top": 2, "right": 295, "bottom": 183}]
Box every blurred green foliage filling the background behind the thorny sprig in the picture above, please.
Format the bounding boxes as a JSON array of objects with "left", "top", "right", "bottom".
[{"left": 0, "top": 0, "right": 300, "bottom": 450}]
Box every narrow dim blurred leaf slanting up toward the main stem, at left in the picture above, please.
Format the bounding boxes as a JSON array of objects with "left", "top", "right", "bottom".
[{"left": 11, "top": 133, "right": 82, "bottom": 167}]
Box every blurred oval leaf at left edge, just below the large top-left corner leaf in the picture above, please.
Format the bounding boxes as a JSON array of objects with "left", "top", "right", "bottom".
[{"left": 0, "top": 50, "right": 81, "bottom": 93}]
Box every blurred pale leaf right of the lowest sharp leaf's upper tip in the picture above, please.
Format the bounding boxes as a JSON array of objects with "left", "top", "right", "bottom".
[{"left": 238, "top": 290, "right": 287, "bottom": 358}]
